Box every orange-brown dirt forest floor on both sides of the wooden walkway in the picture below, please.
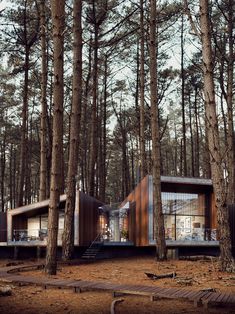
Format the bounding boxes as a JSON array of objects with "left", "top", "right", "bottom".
[{"left": 0, "top": 257, "right": 235, "bottom": 314}]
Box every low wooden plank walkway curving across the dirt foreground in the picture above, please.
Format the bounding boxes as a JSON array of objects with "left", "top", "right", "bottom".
[{"left": 0, "top": 264, "right": 235, "bottom": 308}]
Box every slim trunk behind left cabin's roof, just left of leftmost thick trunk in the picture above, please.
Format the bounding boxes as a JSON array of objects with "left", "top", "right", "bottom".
[{"left": 39, "top": 0, "right": 47, "bottom": 201}]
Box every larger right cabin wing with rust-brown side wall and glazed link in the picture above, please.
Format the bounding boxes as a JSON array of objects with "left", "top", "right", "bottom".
[{"left": 100, "top": 176, "right": 218, "bottom": 247}]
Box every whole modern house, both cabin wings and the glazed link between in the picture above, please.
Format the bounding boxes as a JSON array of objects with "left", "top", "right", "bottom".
[{"left": 0, "top": 175, "right": 235, "bottom": 255}]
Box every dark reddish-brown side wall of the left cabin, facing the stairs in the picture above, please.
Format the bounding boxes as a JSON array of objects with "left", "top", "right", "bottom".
[{"left": 79, "top": 192, "right": 103, "bottom": 246}]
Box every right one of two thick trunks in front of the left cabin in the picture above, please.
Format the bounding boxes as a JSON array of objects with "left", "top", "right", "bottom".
[{"left": 62, "top": 0, "right": 82, "bottom": 260}]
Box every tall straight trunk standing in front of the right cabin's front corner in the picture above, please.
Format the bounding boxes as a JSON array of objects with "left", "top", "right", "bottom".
[{"left": 149, "top": 0, "right": 166, "bottom": 260}]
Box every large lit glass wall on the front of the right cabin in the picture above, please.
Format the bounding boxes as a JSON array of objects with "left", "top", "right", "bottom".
[{"left": 162, "top": 192, "right": 207, "bottom": 241}]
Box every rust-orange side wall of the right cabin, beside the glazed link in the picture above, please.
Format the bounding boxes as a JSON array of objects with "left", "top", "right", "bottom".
[{"left": 127, "top": 176, "right": 149, "bottom": 246}]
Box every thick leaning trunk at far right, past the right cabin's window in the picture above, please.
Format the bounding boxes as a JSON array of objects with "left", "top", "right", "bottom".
[{"left": 200, "top": 0, "right": 235, "bottom": 272}]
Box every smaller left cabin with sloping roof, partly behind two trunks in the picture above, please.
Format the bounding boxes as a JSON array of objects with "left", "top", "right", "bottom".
[{"left": 7, "top": 191, "right": 103, "bottom": 246}]
